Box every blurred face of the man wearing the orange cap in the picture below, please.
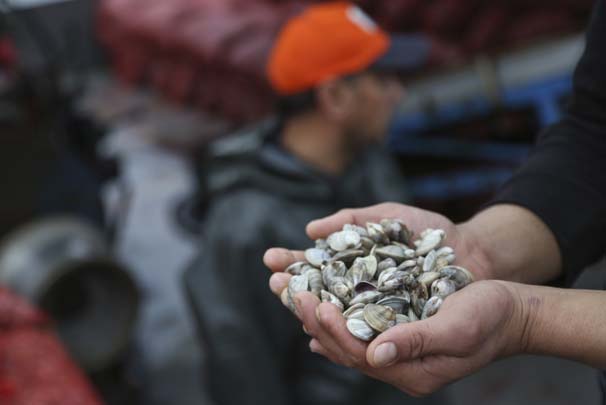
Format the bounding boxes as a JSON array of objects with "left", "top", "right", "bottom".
[{"left": 344, "top": 73, "right": 404, "bottom": 144}]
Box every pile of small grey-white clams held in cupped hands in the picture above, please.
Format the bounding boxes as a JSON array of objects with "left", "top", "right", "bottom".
[{"left": 282, "top": 219, "right": 473, "bottom": 341}]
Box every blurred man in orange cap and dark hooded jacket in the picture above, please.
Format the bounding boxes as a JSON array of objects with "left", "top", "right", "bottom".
[{"left": 187, "top": 3, "right": 444, "bottom": 405}]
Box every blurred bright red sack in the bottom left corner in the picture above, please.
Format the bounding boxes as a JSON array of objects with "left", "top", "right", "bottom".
[{"left": 0, "top": 288, "right": 101, "bottom": 405}]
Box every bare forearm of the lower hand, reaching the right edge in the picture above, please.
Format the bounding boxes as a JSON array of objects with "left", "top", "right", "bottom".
[{"left": 517, "top": 284, "right": 606, "bottom": 369}]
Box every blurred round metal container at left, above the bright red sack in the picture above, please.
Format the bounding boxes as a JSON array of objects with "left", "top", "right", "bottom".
[{"left": 0, "top": 218, "right": 139, "bottom": 372}]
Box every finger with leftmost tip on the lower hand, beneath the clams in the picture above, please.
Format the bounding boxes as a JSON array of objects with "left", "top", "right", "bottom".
[{"left": 295, "top": 293, "right": 354, "bottom": 367}]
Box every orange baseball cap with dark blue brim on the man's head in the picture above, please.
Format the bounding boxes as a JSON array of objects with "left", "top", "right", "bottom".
[{"left": 267, "top": 2, "right": 430, "bottom": 96}]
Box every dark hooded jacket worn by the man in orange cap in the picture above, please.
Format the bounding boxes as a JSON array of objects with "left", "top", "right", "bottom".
[{"left": 186, "top": 119, "right": 446, "bottom": 405}]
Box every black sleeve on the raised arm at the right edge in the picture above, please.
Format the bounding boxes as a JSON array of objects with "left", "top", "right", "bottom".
[{"left": 493, "top": 0, "right": 606, "bottom": 281}]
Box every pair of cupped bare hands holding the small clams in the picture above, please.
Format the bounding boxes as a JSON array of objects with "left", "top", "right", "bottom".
[{"left": 264, "top": 203, "right": 528, "bottom": 396}]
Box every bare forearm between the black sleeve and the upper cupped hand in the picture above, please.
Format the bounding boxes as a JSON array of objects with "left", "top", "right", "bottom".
[{"left": 458, "top": 205, "right": 562, "bottom": 284}]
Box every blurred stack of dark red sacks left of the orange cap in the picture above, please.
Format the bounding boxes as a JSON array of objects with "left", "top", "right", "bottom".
[{"left": 99, "top": 0, "right": 308, "bottom": 122}]
